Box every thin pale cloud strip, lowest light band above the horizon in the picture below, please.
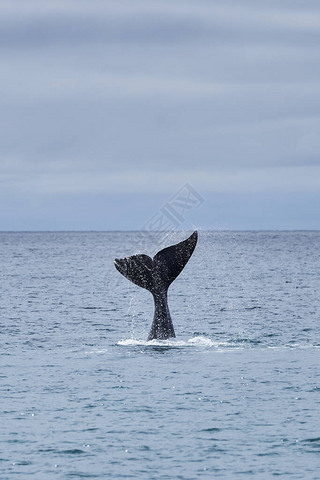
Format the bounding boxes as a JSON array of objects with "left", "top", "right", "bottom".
[{"left": 1, "top": 165, "right": 320, "bottom": 196}]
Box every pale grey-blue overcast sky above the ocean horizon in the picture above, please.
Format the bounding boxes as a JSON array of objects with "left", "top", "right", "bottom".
[{"left": 0, "top": 0, "right": 320, "bottom": 230}]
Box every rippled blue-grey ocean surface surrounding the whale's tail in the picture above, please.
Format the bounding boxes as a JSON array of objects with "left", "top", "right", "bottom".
[{"left": 0, "top": 232, "right": 320, "bottom": 480}]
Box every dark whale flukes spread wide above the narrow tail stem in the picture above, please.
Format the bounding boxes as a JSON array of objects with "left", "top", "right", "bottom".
[{"left": 114, "top": 231, "right": 198, "bottom": 295}]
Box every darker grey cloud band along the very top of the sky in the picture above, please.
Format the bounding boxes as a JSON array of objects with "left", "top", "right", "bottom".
[{"left": 0, "top": 1, "right": 320, "bottom": 49}]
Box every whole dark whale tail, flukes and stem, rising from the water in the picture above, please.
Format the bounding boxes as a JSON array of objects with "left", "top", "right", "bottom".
[{"left": 114, "top": 231, "right": 198, "bottom": 341}]
